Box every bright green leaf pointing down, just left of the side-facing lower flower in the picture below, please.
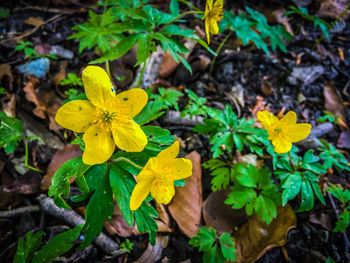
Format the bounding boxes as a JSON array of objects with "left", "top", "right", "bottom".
[{"left": 109, "top": 163, "right": 136, "bottom": 226}]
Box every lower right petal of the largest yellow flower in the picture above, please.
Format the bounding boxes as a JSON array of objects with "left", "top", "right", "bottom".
[{"left": 112, "top": 119, "right": 147, "bottom": 152}]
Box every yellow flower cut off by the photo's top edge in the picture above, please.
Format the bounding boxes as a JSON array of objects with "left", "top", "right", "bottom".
[{"left": 203, "top": 0, "right": 224, "bottom": 44}]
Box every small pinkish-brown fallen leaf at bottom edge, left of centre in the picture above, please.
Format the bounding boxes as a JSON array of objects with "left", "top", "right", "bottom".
[{"left": 134, "top": 235, "right": 169, "bottom": 263}]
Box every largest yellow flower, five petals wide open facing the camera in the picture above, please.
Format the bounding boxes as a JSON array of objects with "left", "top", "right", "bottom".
[{"left": 56, "top": 66, "right": 148, "bottom": 165}]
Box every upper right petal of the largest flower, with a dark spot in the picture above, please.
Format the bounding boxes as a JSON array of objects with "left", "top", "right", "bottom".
[{"left": 112, "top": 89, "right": 148, "bottom": 117}]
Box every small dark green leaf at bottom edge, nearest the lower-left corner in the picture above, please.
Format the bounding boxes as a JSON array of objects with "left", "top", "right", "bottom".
[{"left": 13, "top": 231, "right": 45, "bottom": 263}]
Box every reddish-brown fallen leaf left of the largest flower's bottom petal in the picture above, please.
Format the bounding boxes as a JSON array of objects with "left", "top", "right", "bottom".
[{"left": 40, "top": 144, "right": 81, "bottom": 191}]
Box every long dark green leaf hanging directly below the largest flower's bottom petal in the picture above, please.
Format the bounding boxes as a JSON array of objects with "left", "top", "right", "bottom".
[{"left": 80, "top": 164, "right": 114, "bottom": 248}]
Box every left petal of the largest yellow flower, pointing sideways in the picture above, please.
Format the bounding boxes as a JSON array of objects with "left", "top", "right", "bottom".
[{"left": 55, "top": 100, "right": 95, "bottom": 132}]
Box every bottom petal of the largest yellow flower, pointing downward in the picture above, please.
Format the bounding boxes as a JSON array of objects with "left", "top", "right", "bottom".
[{"left": 83, "top": 125, "right": 115, "bottom": 165}]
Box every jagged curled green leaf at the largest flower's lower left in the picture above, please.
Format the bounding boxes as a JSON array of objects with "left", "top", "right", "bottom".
[{"left": 48, "top": 157, "right": 90, "bottom": 208}]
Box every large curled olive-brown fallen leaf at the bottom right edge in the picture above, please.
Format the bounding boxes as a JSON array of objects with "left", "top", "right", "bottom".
[{"left": 233, "top": 205, "right": 296, "bottom": 263}]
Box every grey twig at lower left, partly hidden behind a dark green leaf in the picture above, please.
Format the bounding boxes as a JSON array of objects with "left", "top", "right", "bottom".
[{"left": 37, "top": 194, "right": 125, "bottom": 256}]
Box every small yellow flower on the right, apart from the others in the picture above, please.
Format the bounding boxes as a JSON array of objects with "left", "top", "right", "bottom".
[{"left": 257, "top": 111, "right": 312, "bottom": 153}]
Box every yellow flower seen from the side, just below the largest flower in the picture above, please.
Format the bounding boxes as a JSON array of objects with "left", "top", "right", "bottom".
[{"left": 130, "top": 141, "right": 192, "bottom": 210}]
